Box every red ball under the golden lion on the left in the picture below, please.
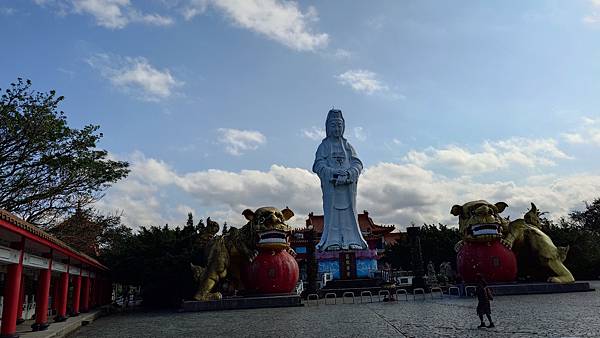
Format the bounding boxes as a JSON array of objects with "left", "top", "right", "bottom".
[{"left": 242, "top": 250, "right": 299, "bottom": 294}]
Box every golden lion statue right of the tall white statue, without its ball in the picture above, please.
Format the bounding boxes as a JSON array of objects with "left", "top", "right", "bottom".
[{"left": 450, "top": 200, "right": 575, "bottom": 283}]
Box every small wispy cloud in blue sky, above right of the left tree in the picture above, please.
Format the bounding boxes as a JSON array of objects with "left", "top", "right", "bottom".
[{"left": 86, "top": 54, "right": 183, "bottom": 101}]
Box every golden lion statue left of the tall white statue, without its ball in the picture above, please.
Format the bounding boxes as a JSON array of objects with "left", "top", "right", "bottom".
[{"left": 191, "top": 207, "right": 294, "bottom": 301}]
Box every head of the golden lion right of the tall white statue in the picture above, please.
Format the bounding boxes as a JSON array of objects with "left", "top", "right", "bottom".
[{"left": 450, "top": 200, "right": 508, "bottom": 241}]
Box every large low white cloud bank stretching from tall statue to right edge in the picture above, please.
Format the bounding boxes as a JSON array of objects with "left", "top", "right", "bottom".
[{"left": 357, "top": 163, "right": 600, "bottom": 226}]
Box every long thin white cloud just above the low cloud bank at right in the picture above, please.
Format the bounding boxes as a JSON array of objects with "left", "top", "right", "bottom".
[{"left": 405, "top": 138, "right": 570, "bottom": 174}]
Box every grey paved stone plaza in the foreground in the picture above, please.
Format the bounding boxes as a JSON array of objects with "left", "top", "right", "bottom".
[{"left": 73, "top": 282, "right": 600, "bottom": 337}]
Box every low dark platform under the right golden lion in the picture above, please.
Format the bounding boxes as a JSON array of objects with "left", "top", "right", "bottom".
[{"left": 489, "top": 282, "right": 594, "bottom": 296}]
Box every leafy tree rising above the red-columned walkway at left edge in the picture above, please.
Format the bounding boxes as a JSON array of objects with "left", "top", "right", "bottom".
[{"left": 0, "top": 79, "right": 129, "bottom": 225}]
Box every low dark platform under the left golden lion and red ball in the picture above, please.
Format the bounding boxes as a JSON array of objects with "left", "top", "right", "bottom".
[{"left": 181, "top": 295, "right": 303, "bottom": 312}]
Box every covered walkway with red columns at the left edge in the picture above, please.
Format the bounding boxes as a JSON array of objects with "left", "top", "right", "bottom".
[{"left": 0, "top": 210, "right": 111, "bottom": 337}]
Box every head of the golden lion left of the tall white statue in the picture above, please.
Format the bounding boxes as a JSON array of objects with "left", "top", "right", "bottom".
[{"left": 242, "top": 207, "right": 294, "bottom": 249}]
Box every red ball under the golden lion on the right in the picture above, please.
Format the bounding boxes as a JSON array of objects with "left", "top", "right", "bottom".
[{"left": 456, "top": 240, "right": 517, "bottom": 283}]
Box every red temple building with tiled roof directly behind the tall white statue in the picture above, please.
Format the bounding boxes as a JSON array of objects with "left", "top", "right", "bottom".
[{"left": 290, "top": 210, "right": 406, "bottom": 281}]
